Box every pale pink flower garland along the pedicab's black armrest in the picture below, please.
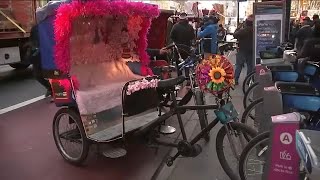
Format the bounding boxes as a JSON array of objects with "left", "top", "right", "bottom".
[{"left": 127, "top": 78, "right": 159, "bottom": 95}]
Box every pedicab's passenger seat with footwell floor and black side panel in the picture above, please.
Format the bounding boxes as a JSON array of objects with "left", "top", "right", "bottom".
[{"left": 71, "top": 61, "right": 159, "bottom": 142}]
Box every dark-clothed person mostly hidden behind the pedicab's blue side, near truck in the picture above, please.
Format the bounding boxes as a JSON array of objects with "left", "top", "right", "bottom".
[{"left": 30, "top": 24, "right": 53, "bottom": 101}]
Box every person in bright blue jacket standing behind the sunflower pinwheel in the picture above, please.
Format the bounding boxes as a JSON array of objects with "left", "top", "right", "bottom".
[{"left": 198, "top": 16, "right": 219, "bottom": 59}]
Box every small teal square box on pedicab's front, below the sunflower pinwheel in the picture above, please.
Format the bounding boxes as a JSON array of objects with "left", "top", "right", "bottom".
[{"left": 214, "top": 102, "right": 238, "bottom": 124}]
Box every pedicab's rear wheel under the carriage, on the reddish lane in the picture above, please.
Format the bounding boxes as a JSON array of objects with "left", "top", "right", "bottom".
[{"left": 52, "top": 108, "right": 90, "bottom": 166}]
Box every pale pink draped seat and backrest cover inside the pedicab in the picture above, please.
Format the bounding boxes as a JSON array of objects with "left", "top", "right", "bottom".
[{"left": 71, "top": 61, "right": 142, "bottom": 114}]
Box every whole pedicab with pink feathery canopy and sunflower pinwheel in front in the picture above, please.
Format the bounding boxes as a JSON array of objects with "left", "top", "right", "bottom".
[{"left": 39, "top": 0, "right": 256, "bottom": 177}]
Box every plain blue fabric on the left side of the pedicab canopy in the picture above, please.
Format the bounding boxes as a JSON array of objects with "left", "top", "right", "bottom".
[{"left": 38, "top": 16, "right": 57, "bottom": 70}]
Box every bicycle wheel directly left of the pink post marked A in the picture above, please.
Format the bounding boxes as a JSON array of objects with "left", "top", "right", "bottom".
[{"left": 239, "top": 132, "right": 270, "bottom": 180}]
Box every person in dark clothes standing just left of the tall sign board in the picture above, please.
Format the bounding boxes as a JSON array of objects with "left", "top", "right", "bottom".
[{"left": 233, "top": 15, "right": 254, "bottom": 85}]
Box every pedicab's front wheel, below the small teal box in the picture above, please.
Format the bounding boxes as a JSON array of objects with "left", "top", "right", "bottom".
[{"left": 216, "top": 122, "right": 257, "bottom": 180}]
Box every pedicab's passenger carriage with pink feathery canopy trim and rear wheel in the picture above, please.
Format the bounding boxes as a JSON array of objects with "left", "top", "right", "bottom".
[{"left": 39, "top": 1, "right": 165, "bottom": 164}]
